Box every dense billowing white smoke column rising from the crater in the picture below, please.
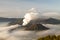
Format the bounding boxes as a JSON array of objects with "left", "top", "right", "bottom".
[{"left": 22, "top": 8, "right": 39, "bottom": 25}]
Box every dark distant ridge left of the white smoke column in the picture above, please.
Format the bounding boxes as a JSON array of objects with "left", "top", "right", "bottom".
[{"left": 0, "top": 17, "right": 23, "bottom": 25}]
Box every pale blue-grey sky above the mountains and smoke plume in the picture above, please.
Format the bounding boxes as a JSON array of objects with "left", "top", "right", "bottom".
[{"left": 0, "top": 0, "right": 60, "bottom": 18}]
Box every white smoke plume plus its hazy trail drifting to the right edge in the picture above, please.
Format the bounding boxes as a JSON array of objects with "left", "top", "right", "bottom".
[{"left": 22, "top": 8, "right": 60, "bottom": 26}]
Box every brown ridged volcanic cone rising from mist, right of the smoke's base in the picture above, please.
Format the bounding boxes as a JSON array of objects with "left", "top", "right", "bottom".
[{"left": 25, "top": 24, "right": 49, "bottom": 31}]
